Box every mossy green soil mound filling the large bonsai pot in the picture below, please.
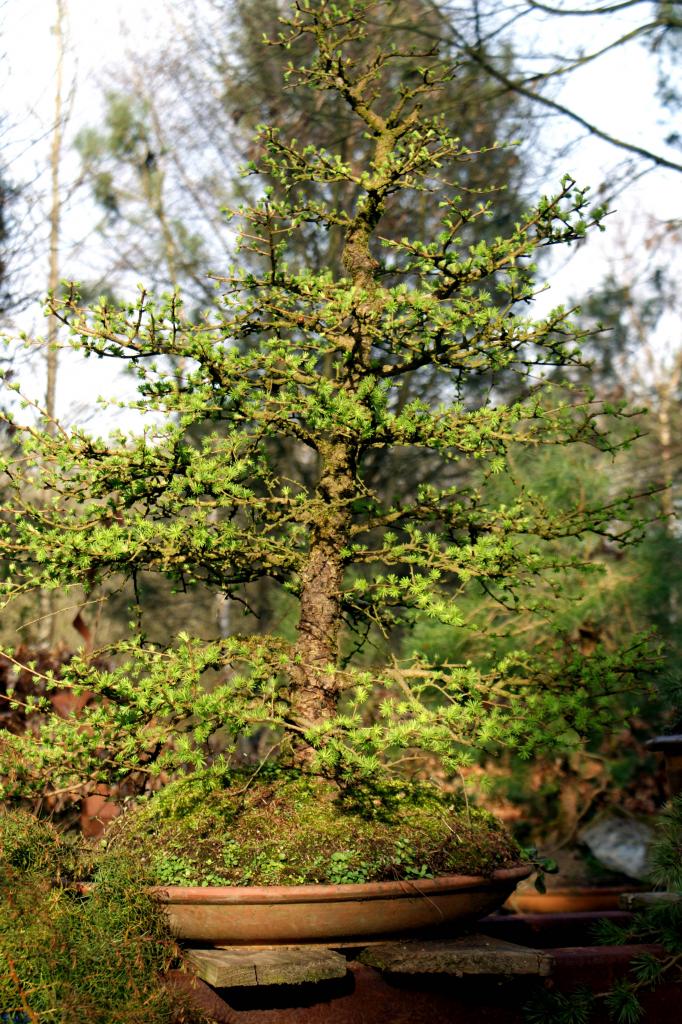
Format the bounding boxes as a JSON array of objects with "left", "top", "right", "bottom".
[{"left": 100, "top": 772, "right": 521, "bottom": 886}]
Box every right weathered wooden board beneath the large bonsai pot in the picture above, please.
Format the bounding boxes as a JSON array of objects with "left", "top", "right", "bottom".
[{"left": 357, "top": 935, "right": 554, "bottom": 978}]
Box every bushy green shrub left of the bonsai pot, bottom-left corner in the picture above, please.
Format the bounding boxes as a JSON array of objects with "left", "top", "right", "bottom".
[{"left": 0, "top": 812, "right": 201, "bottom": 1024}]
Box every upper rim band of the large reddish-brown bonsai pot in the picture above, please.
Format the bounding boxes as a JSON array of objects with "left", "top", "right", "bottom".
[{"left": 151, "top": 864, "right": 534, "bottom": 905}]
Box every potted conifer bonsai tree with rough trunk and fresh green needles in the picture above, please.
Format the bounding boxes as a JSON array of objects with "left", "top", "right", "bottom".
[{"left": 0, "top": 0, "right": 645, "bottom": 860}]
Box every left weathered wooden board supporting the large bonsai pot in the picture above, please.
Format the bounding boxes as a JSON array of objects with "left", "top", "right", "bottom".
[{"left": 185, "top": 946, "right": 346, "bottom": 988}]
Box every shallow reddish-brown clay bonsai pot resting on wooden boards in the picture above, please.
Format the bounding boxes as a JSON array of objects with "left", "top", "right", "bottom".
[{"left": 155, "top": 864, "right": 532, "bottom": 945}]
